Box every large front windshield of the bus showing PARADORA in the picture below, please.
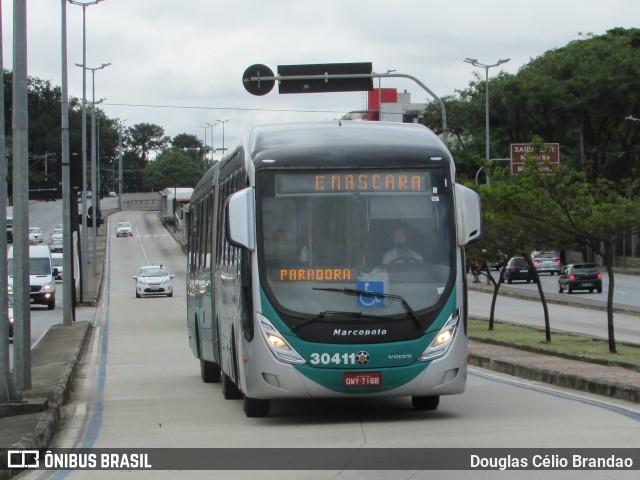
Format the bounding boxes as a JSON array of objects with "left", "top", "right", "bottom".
[{"left": 256, "top": 168, "right": 455, "bottom": 316}]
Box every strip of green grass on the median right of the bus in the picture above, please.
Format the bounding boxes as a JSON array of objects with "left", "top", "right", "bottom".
[{"left": 469, "top": 319, "right": 640, "bottom": 371}]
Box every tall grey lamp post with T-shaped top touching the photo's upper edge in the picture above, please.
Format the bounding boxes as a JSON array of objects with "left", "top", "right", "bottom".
[{"left": 67, "top": 0, "right": 103, "bottom": 300}]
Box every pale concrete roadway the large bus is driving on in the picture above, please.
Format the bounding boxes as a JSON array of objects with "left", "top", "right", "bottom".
[{"left": 16, "top": 212, "right": 640, "bottom": 480}]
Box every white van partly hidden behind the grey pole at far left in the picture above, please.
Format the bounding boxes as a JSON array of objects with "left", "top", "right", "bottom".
[{"left": 7, "top": 245, "right": 58, "bottom": 310}]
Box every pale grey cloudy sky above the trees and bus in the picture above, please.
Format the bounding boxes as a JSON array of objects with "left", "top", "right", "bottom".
[{"left": 0, "top": 0, "right": 640, "bottom": 157}]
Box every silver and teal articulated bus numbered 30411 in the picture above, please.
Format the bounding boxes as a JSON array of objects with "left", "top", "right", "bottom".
[{"left": 185, "top": 121, "right": 481, "bottom": 417}]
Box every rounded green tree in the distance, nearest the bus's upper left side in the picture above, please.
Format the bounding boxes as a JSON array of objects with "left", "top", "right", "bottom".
[{"left": 144, "top": 148, "right": 204, "bottom": 191}]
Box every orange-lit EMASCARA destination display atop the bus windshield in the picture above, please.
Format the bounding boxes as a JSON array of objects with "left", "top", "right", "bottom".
[{"left": 276, "top": 170, "right": 430, "bottom": 195}]
